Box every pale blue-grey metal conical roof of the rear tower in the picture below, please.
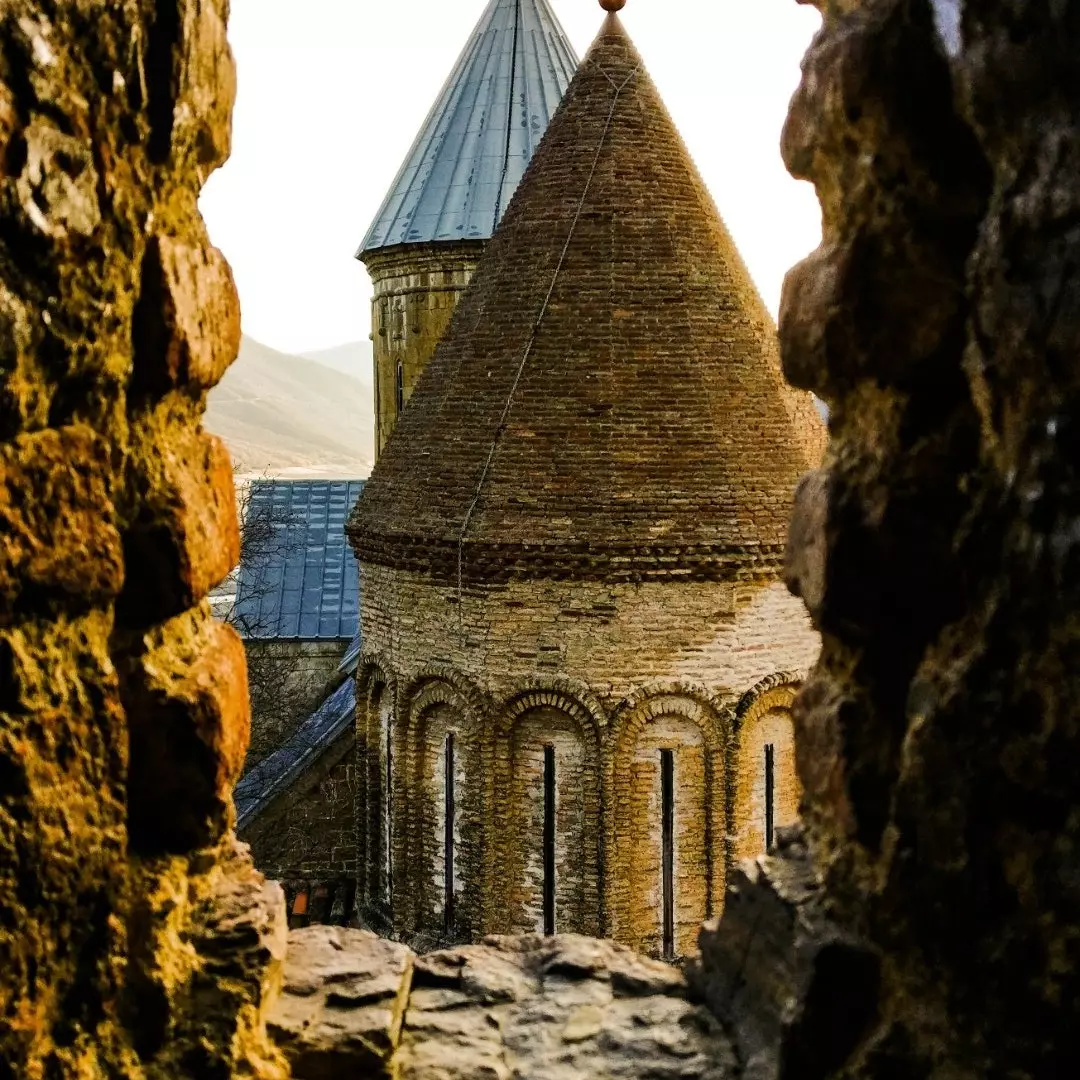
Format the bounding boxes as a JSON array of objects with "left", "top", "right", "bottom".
[{"left": 356, "top": 0, "right": 578, "bottom": 256}]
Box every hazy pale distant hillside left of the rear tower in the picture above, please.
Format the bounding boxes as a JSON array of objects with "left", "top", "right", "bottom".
[{"left": 205, "top": 337, "right": 375, "bottom": 477}]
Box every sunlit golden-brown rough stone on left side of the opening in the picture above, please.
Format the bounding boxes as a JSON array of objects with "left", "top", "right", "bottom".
[{"left": 0, "top": 0, "right": 285, "bottom": 1080}]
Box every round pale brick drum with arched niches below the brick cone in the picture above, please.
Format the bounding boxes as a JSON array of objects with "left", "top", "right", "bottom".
[{"left": 357, "top": 565, "right": 818, "bottom": 955}]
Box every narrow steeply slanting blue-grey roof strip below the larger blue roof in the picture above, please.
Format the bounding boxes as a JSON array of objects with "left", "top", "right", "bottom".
[{"left": 232, "top": 677, "right": 356, "bottom": 828}]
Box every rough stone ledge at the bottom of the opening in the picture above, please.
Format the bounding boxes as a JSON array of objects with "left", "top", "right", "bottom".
[{"left": 270, "top": 927, "right": 735, "bottom": 1080}]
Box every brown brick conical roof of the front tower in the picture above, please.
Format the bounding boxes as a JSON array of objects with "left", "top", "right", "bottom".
[{"left": 350, "top": 15, "right": 824, "bottom": 581}]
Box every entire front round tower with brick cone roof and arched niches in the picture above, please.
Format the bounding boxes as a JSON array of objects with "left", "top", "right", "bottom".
[{"left": 349, "top": 6, "right": 824, "bottom": 956}]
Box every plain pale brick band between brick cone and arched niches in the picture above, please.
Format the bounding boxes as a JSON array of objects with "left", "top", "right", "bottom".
[{"left": 361, "top": 564, "right": 820, "bottom": 702}]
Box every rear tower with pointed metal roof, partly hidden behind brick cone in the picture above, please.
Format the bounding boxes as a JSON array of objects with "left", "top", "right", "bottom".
[{"left": 356, "top": 0, "right": 578, "bottom": 458}]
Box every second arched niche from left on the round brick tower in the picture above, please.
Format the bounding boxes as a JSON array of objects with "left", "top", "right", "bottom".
[{"left": 391, "top": 678, "right": 484, "bottom": 948}]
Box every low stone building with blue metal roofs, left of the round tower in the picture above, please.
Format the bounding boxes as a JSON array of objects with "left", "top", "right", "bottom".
[{"left": 229, "top": 480, "right": 364, "bottom": 924}]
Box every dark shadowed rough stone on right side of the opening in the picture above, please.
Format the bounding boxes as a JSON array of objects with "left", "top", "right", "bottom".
[{"left": 703, "top": 0, "right": 1080, "bottom": 1080}]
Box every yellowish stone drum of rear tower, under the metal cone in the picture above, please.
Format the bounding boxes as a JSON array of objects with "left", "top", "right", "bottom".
[{"left": 364, "top": 241, "right": 484, "bottom": 459}]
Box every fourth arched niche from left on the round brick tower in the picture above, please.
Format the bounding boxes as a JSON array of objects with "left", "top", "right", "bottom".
[{"left": 607, "top": 690, "right": 727, "bottom": 958}]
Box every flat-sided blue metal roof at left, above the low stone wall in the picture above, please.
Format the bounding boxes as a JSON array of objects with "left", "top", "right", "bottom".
[{"left": 230, "top": 480, "right": 364, "bottom": 640}]
